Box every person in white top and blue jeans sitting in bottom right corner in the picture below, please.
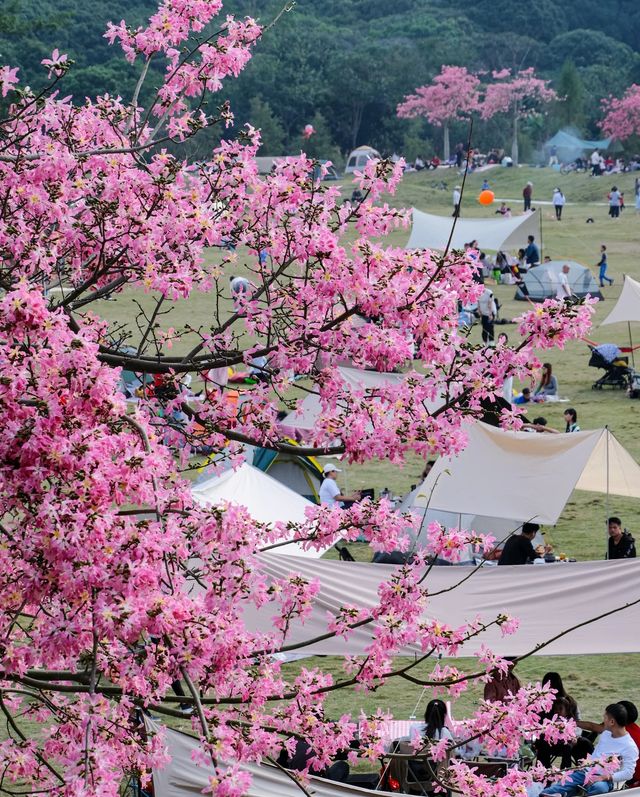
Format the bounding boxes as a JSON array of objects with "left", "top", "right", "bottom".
[{"left": 541, "top": 703, "right": 638, "bottom": 797}]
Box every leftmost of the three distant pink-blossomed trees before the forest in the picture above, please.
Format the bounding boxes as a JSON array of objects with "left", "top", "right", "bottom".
[{"left": 398, "top": 66, "right": 480, "bottom": 161}]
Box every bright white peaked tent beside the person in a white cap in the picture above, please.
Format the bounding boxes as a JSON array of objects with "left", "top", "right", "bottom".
[{"left": 192, "top": 462, "right": 323, "bottom": 558}]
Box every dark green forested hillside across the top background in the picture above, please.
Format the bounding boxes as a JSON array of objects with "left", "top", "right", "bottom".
[{"left": 0, "top": 0, "right": 640, "bottom": 163}]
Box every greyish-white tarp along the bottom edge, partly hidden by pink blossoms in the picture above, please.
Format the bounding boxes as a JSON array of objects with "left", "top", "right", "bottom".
[{"left": 151, "top": 718, "right": 400, "bottom": 797}]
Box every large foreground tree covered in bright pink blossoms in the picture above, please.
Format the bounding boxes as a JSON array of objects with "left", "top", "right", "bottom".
[{"left": 0, "top": 0, "right": 591, "bottom": 797}]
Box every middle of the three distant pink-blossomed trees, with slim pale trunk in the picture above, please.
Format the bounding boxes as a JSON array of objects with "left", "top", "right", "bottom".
[{"left": 481, "top": 67, "right": 558, "bottom": 164}]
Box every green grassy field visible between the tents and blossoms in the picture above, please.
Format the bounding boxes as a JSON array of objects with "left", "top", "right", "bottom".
[{"left": 82, "top": 168, "right": 640, "bottom": 732}]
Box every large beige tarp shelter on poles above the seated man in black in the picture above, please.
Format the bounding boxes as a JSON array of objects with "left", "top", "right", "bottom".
[{"left": 416, "top": 422, "right": 640, "bottom": 524}]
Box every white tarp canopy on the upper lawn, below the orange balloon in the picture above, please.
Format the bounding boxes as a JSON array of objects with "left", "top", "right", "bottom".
[{"left": 405, "top": 208, "right": 540, "bottom": 252}]
